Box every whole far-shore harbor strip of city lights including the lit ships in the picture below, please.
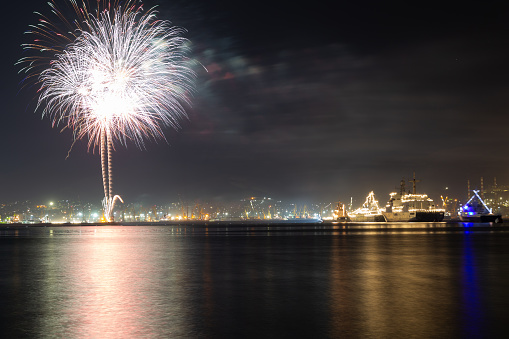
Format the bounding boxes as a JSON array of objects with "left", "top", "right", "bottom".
[{"left": 0, "top": 174, "right": 509, "bottom": 226}]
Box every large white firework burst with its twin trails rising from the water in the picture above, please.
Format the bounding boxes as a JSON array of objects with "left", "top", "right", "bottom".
[{"left": 18, "top": 0, "right": 195, "bottom": 221}]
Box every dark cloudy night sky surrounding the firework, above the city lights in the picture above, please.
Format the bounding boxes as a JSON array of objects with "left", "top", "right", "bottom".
[{"left": 0, "top": 0, "right": 509, "bottom": 204}]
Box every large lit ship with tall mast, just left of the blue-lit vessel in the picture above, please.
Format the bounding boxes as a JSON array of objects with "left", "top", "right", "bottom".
[{"left": 382, "top": 173, "right": 445, "bottom": 222}]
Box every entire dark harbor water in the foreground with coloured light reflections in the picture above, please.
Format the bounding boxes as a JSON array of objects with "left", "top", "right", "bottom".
[{"left": 0, "top": 224, "right": 509, "bottom": 338}]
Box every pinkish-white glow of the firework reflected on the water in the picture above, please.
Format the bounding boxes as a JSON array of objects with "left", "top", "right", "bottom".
[{"left": 37, "top": 229, "right": 189, "bottom": 338}]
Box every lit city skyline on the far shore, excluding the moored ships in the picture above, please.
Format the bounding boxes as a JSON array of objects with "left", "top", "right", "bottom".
[{"left": 4, "top": 177, "right": 509, "bottom": 224}]
